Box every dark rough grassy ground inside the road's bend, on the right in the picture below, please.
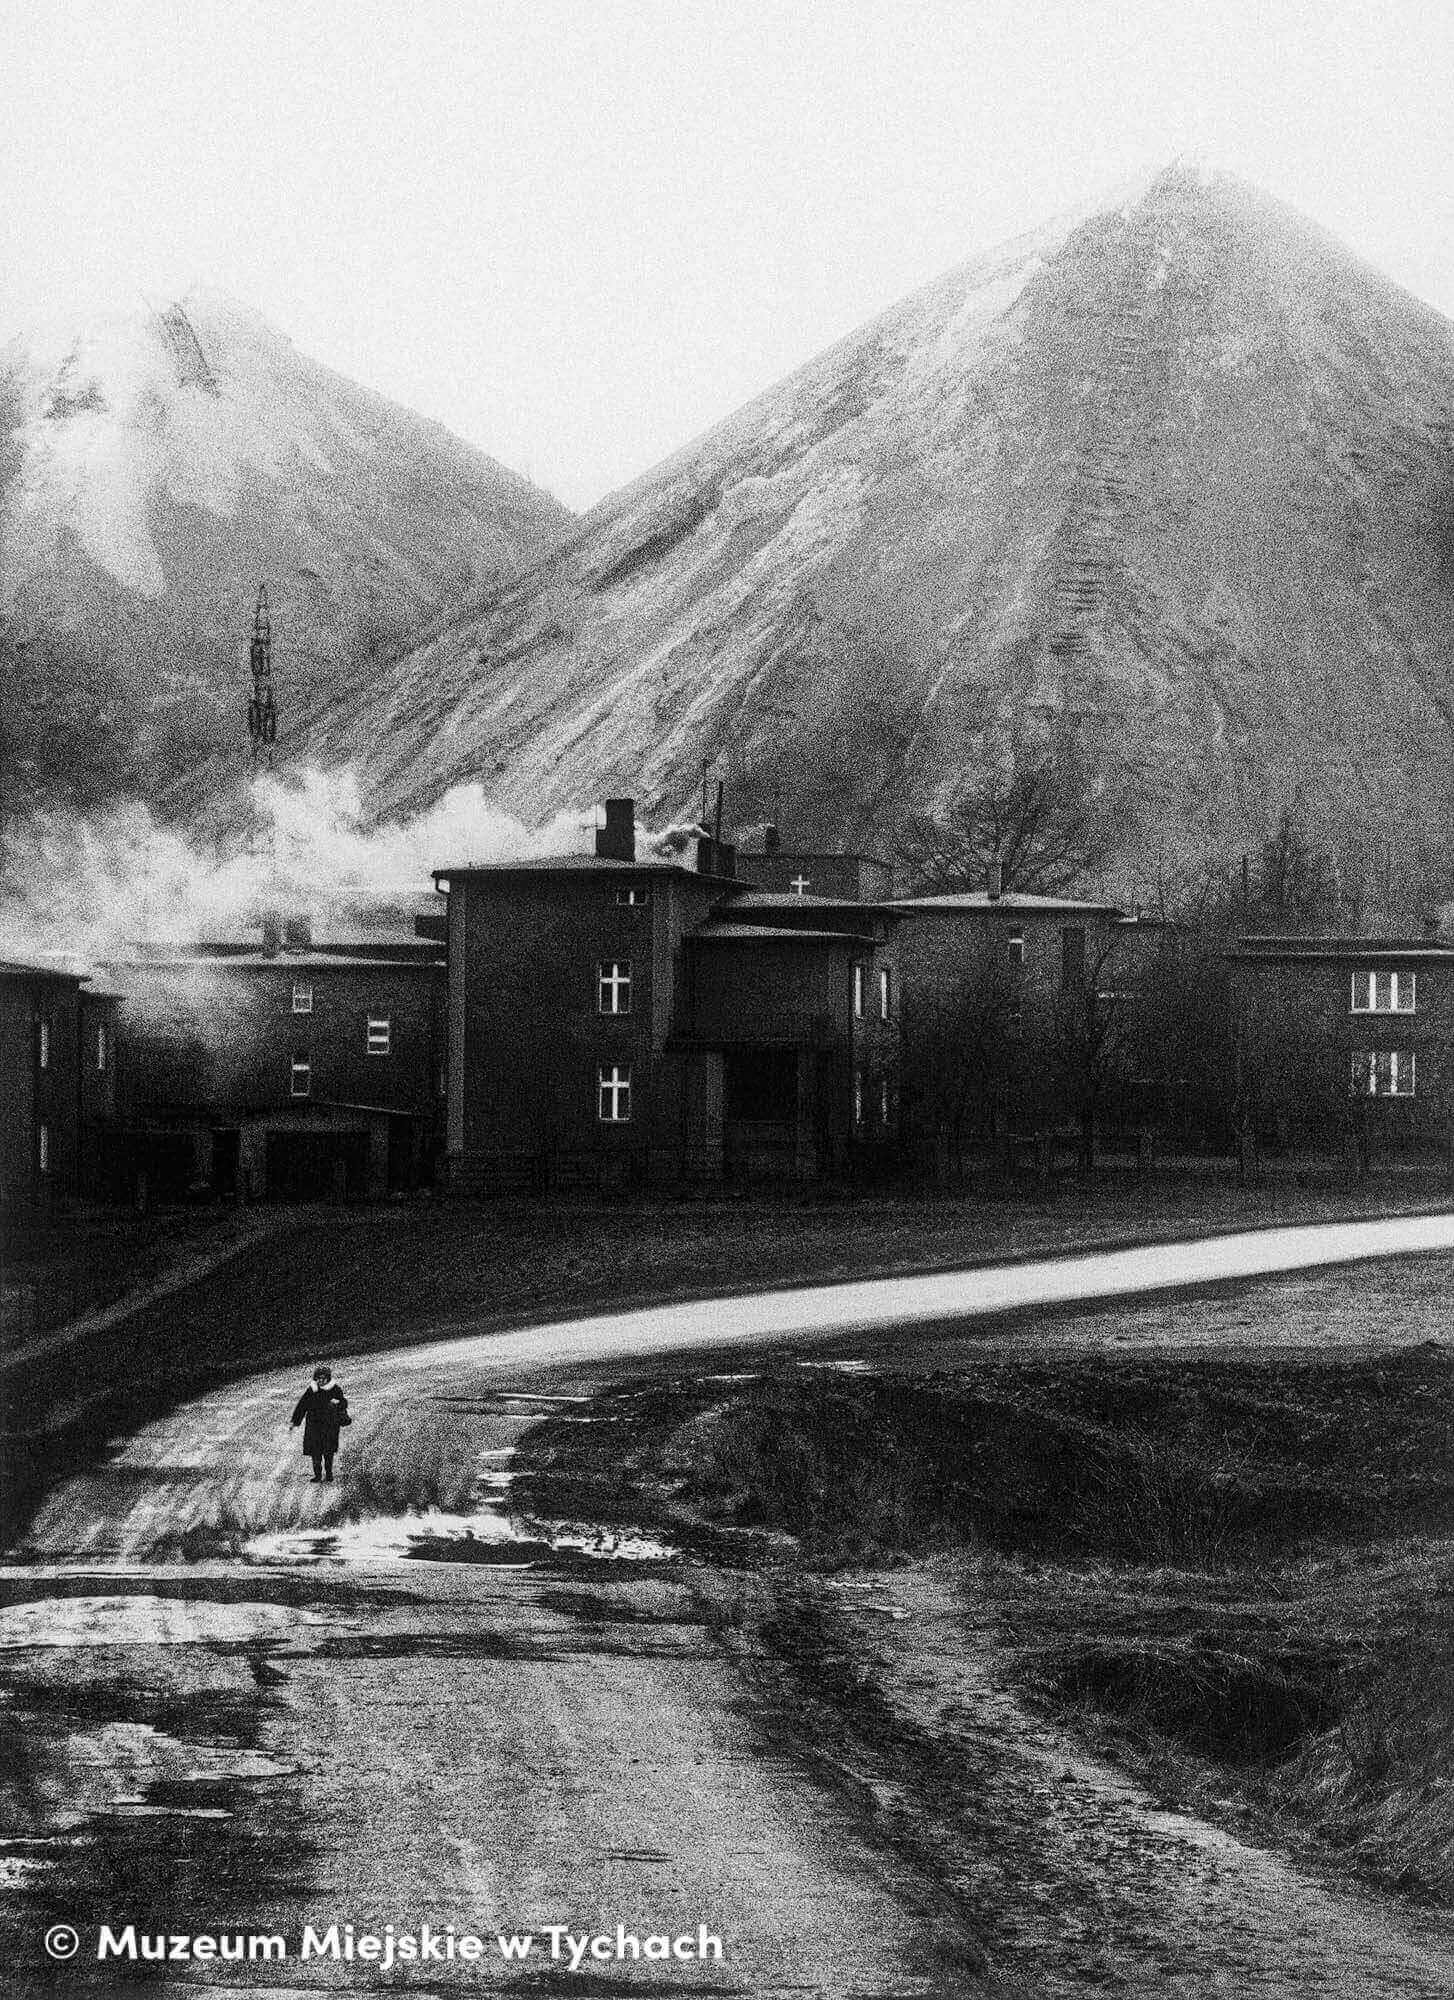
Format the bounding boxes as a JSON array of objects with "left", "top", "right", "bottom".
[{"left": 524, "top": 1288, "right": 1454, "bottom": 1904}]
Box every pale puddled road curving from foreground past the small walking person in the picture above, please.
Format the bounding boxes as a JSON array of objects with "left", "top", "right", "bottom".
[{"left": 0, "top": 1214, "right": 1454, "bottom": 2000}]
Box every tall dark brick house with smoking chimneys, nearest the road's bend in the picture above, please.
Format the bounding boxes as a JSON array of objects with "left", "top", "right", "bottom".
[{"left": 436, "top": 800, "right": 898, "bottom": 1186}]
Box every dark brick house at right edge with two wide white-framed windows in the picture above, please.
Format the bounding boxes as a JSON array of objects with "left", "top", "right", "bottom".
[{"left": 1228, "top": 936, "right": 1454, "bottom": 1152}]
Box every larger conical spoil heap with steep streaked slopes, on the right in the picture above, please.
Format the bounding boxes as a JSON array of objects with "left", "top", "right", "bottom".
[{"left": 292, "top": 166, "right": 1454, "bottom": 888}]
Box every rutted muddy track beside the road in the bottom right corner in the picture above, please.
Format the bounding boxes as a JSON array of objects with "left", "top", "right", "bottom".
[{"left": 752, "top": 1554, "right": 1454, "bottom": 2000}]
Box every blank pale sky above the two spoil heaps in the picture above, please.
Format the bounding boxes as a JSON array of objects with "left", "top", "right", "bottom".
[{"left": 0, "top": 0, "right": 1454, "bottom": 508}]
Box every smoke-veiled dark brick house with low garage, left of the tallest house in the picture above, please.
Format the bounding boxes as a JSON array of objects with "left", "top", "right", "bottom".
[{"left": 124, "top": 908, "right": 444, "bottom": 1200}]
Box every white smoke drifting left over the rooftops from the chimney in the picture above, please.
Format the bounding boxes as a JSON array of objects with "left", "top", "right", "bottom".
[{"left": 0, "top": 770, "right": 594, "bottom": 972}]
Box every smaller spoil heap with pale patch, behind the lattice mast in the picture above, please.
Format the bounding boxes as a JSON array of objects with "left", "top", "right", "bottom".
[{"left": 0, "top": 292, "right": 570, "bottom": 808}]
